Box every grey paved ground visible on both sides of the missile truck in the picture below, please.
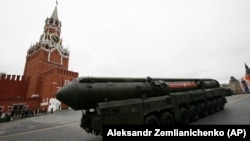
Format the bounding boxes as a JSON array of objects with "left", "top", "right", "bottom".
[{"left": 0, "top": 94, "right": 250, "bottom": 141}]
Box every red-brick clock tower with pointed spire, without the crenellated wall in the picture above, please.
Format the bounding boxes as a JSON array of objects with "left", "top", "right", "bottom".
[{"left": 23, "top": 5, "right": 78, "bottom": 106}]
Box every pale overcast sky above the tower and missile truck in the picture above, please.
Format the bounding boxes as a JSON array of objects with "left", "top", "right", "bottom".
[{"left": 0, "top": 0, "right": 250, "bottom": 83}]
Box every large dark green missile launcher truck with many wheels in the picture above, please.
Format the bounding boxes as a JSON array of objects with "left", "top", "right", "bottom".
[{"left": 56, "top": 77, "right": 227, "bottom": 134}]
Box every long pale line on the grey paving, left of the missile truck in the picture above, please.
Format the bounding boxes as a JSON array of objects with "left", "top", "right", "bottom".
[{"left": 0, "top": 122, "right": 79, "bottom": 138}]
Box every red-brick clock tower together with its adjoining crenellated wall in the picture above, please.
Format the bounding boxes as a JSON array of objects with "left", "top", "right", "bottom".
[{"left": 0, "top": 6, "right": 78, "bottom": 112}]
